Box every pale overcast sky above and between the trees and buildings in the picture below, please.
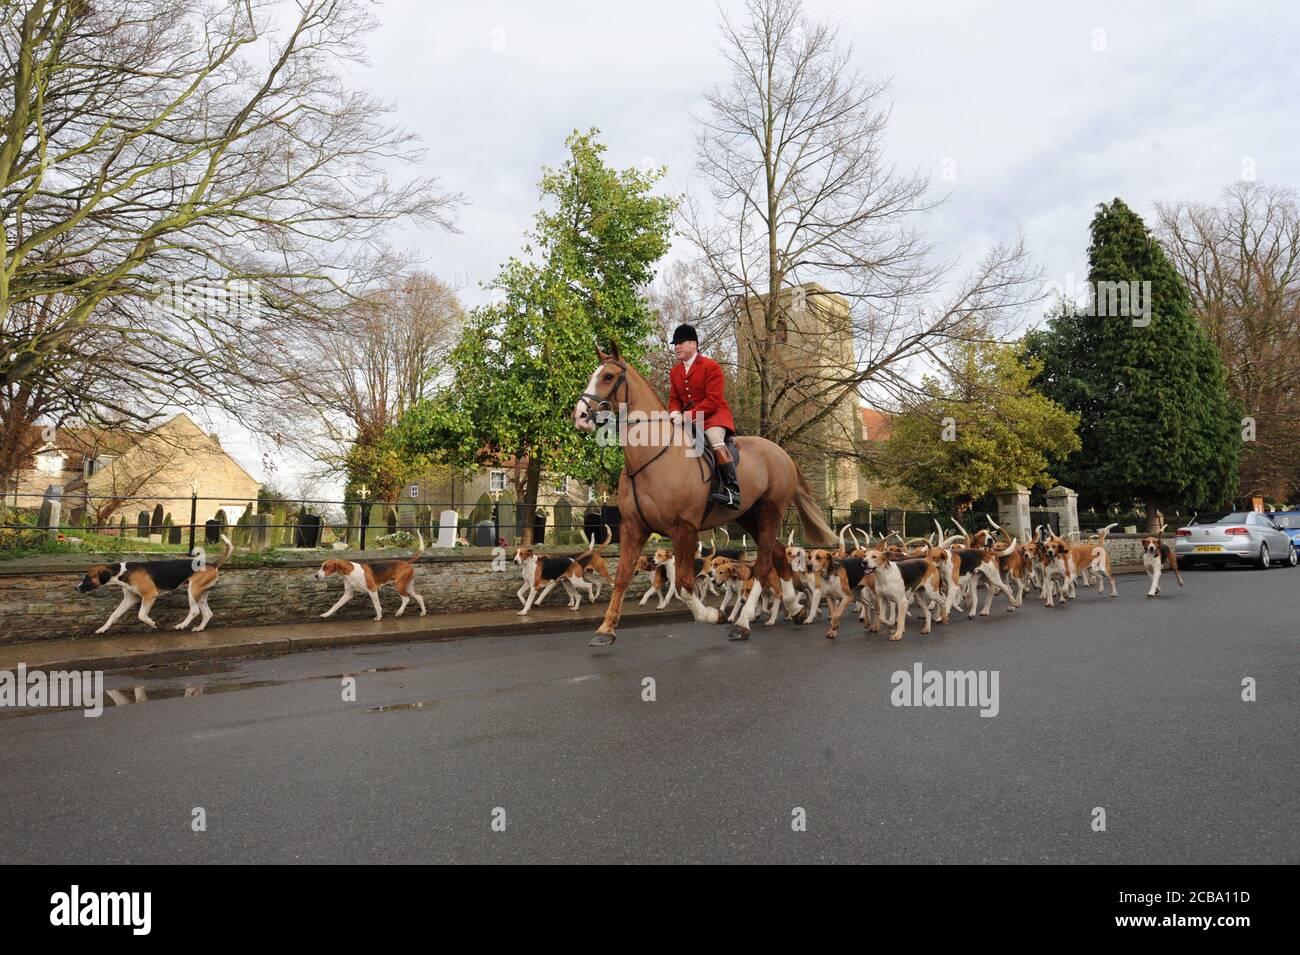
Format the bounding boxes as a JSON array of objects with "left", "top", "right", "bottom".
[{"left": 218, "top": 0, "right": 1300, "bottom": 485}]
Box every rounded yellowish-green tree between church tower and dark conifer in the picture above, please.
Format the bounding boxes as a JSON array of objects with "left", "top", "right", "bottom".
[{"left": 872, "top": 342, "right": 1079, "bottom": 512}]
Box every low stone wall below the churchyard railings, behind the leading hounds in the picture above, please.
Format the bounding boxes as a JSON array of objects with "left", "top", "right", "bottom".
[{"left": 0, "top": 555, "right": 649, "bottom": 643}]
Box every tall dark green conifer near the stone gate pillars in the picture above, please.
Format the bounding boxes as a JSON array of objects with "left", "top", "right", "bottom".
[{"left": 1026, "top": 199, "right": 1240, "bottom": 530}]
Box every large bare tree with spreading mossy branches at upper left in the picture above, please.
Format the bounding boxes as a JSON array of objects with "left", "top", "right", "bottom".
[{"left": 0, "top": 0, "right": 460, "bottom": 493}]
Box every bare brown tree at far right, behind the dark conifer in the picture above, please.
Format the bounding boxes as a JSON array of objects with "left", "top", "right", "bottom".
[{"left": 1156, "top": 182, "right": 1300, "bottom": 498}]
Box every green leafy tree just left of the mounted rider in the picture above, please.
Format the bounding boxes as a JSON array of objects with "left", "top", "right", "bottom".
[{"left": 393, "top": 129, "right": 675, "bottom": 535}]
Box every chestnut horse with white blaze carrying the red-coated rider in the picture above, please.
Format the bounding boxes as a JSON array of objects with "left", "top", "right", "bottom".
[{"left": 573, "top": 343, "right": 835, "bottom": 647}]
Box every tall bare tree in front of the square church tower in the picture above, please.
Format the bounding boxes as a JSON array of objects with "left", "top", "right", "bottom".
[{"left": 681, "top": 0, "right": 1039, "bottom": 467}]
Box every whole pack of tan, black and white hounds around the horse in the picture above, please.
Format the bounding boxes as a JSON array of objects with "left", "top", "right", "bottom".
[{"left": 77, "top": 518, "right": 1183, "bottom": 641}]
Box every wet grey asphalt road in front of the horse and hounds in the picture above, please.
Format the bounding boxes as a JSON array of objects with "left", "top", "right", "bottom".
[{"left": 0, "top": 568, "right": 1300, "bottom": 863}]
